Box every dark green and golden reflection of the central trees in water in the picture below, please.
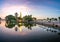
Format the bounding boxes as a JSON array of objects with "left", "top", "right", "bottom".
[{"left": 5, "top": 22, "right": 36, "bottom": 31}]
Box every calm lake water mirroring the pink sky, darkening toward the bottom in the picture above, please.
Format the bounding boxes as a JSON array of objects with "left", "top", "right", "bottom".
[{"left": 0, "top": 21, "right": 60, "bottom": 42}]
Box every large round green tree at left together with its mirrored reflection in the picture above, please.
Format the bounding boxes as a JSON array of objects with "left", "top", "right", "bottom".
[{"left": 5, "top": 15, "right": 16, "bottom": 28}]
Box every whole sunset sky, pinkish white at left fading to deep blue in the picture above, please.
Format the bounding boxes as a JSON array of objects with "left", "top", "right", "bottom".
[{"left": 0, "top": 0, "right": 60, "bottom": 19}]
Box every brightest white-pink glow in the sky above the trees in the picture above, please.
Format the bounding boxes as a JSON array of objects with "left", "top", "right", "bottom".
[{"left": 2, "top": 5, "right": 30, "bottom": 16}]
